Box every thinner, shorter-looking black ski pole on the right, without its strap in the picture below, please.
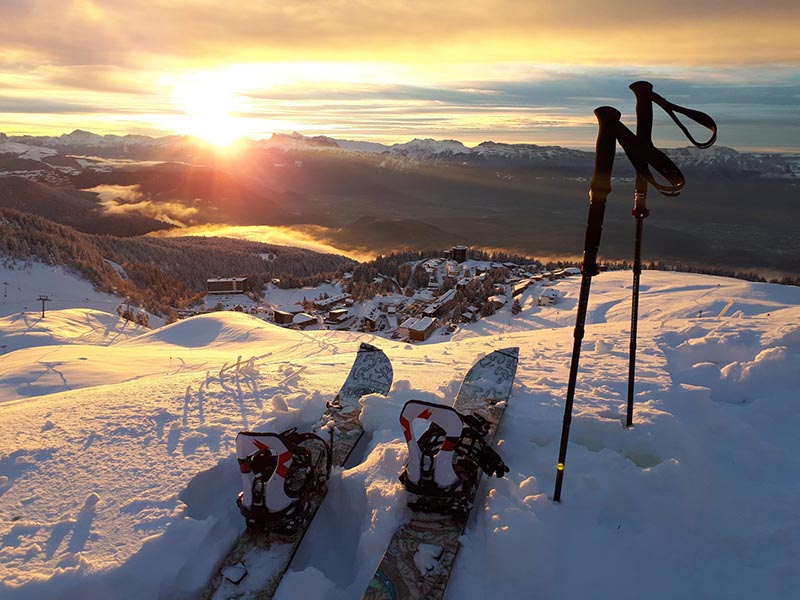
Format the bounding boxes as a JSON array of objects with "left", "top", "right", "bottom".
[{"left": 625, "top": 81, "right": 653, "bottom": 427}]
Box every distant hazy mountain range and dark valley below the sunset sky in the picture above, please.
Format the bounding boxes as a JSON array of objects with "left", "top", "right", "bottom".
[{"left": 0, "top": 130, "right": 800, "bottom": 275}]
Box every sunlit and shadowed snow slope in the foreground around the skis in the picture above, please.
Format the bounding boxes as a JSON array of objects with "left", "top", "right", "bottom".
[{"left": 0, "top": 271, "right": 800, "bottom": 600}]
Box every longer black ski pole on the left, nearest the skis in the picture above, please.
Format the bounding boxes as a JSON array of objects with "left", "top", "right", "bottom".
[{"left": 553, "top": 106, "right": 620, "bottom": 502}]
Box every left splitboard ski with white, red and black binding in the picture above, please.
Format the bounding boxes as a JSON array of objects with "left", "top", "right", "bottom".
[{"left": 202, "top": 342, "right": 393, "bottom": 600}]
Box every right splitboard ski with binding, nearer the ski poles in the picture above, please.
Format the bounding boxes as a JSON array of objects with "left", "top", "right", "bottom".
[{"left": 363, "top": 348, "right": 519, "bottom": 600}]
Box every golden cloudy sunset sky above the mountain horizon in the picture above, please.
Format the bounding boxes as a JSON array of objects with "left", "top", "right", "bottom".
[{"left": 0, "top": 0, "right": 800, "bottom": 152}]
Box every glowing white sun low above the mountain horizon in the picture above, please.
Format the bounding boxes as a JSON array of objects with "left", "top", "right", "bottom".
[{"left": 172, "top": 73, "right": 250, "bottom": 147}]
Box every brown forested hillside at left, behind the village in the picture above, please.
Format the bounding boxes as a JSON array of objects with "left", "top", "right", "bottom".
[{"left": 0, "top": 208, "right": 353, "bottom": 315}]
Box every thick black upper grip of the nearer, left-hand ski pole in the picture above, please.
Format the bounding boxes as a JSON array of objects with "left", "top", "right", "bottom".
[{"left": 582, "top": 106, "right": 620, "bottom": 276}]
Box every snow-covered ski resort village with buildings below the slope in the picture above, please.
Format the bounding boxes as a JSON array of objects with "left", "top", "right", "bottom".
[{"left": 198, "top": 246, "right": 580, "bottom": 342}]
